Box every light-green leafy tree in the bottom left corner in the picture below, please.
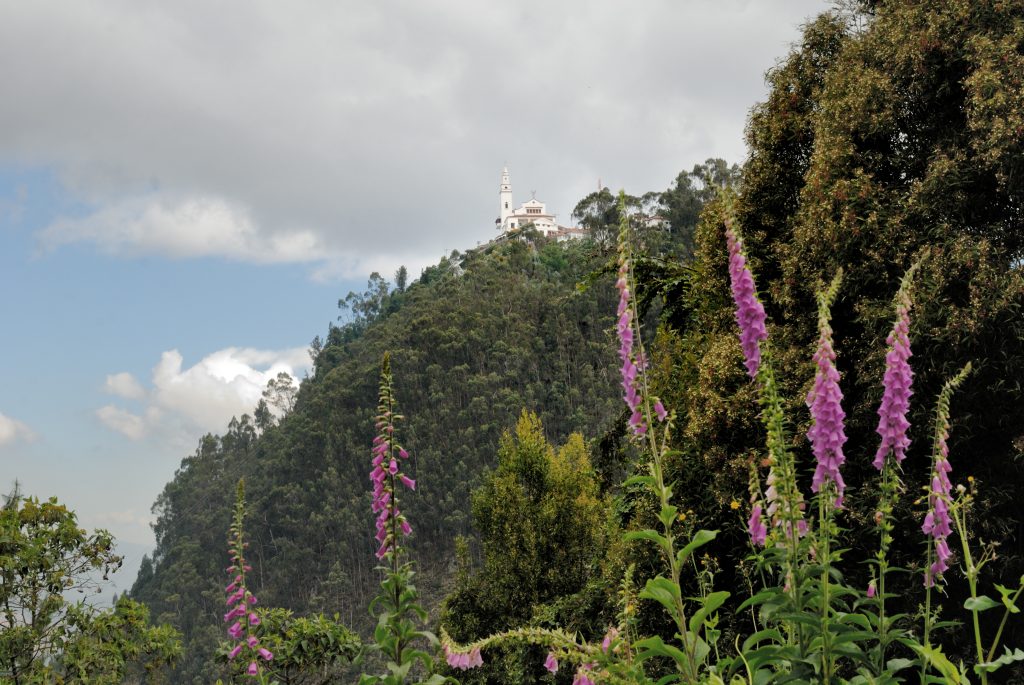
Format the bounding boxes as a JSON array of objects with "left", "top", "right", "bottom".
[{"left": 0, "top": 495, "right": 180, "bottom": 684}]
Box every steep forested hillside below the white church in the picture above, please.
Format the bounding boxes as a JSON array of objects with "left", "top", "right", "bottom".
[{"left": 126, "top": 236, "right": 620, "bottom": 682}]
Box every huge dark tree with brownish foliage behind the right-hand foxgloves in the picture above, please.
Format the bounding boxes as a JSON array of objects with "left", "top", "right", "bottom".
[{"left": 652, "top": 1, "right": 1024, "bottom": 663}]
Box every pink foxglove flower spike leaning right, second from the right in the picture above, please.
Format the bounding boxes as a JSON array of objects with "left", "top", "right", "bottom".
[{"left": 873, "top": 264, "right": 918, "bottom": 471}]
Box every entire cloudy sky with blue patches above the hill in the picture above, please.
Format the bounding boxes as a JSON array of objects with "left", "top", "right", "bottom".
[{"left": 0, "top": 0, "right": 830, "bottom": 585}]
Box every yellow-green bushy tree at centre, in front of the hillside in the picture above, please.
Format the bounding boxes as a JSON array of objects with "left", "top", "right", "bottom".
[{"left": 441, "top": 412, "right": 609, "bottom": 682}]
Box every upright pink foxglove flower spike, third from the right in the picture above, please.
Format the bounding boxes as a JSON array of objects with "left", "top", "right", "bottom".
[{"left": 807, "top": 274, "right": 846, "bottom": 509}]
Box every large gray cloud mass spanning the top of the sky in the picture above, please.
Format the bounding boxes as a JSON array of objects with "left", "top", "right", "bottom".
[{"left": 0, "top": 0, "right": 827, "bottom": 274}]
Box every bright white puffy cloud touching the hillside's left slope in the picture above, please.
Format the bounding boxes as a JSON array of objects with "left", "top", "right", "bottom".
[{"left": 96, "top": 347, "right": 309, "bottom": 440}]
